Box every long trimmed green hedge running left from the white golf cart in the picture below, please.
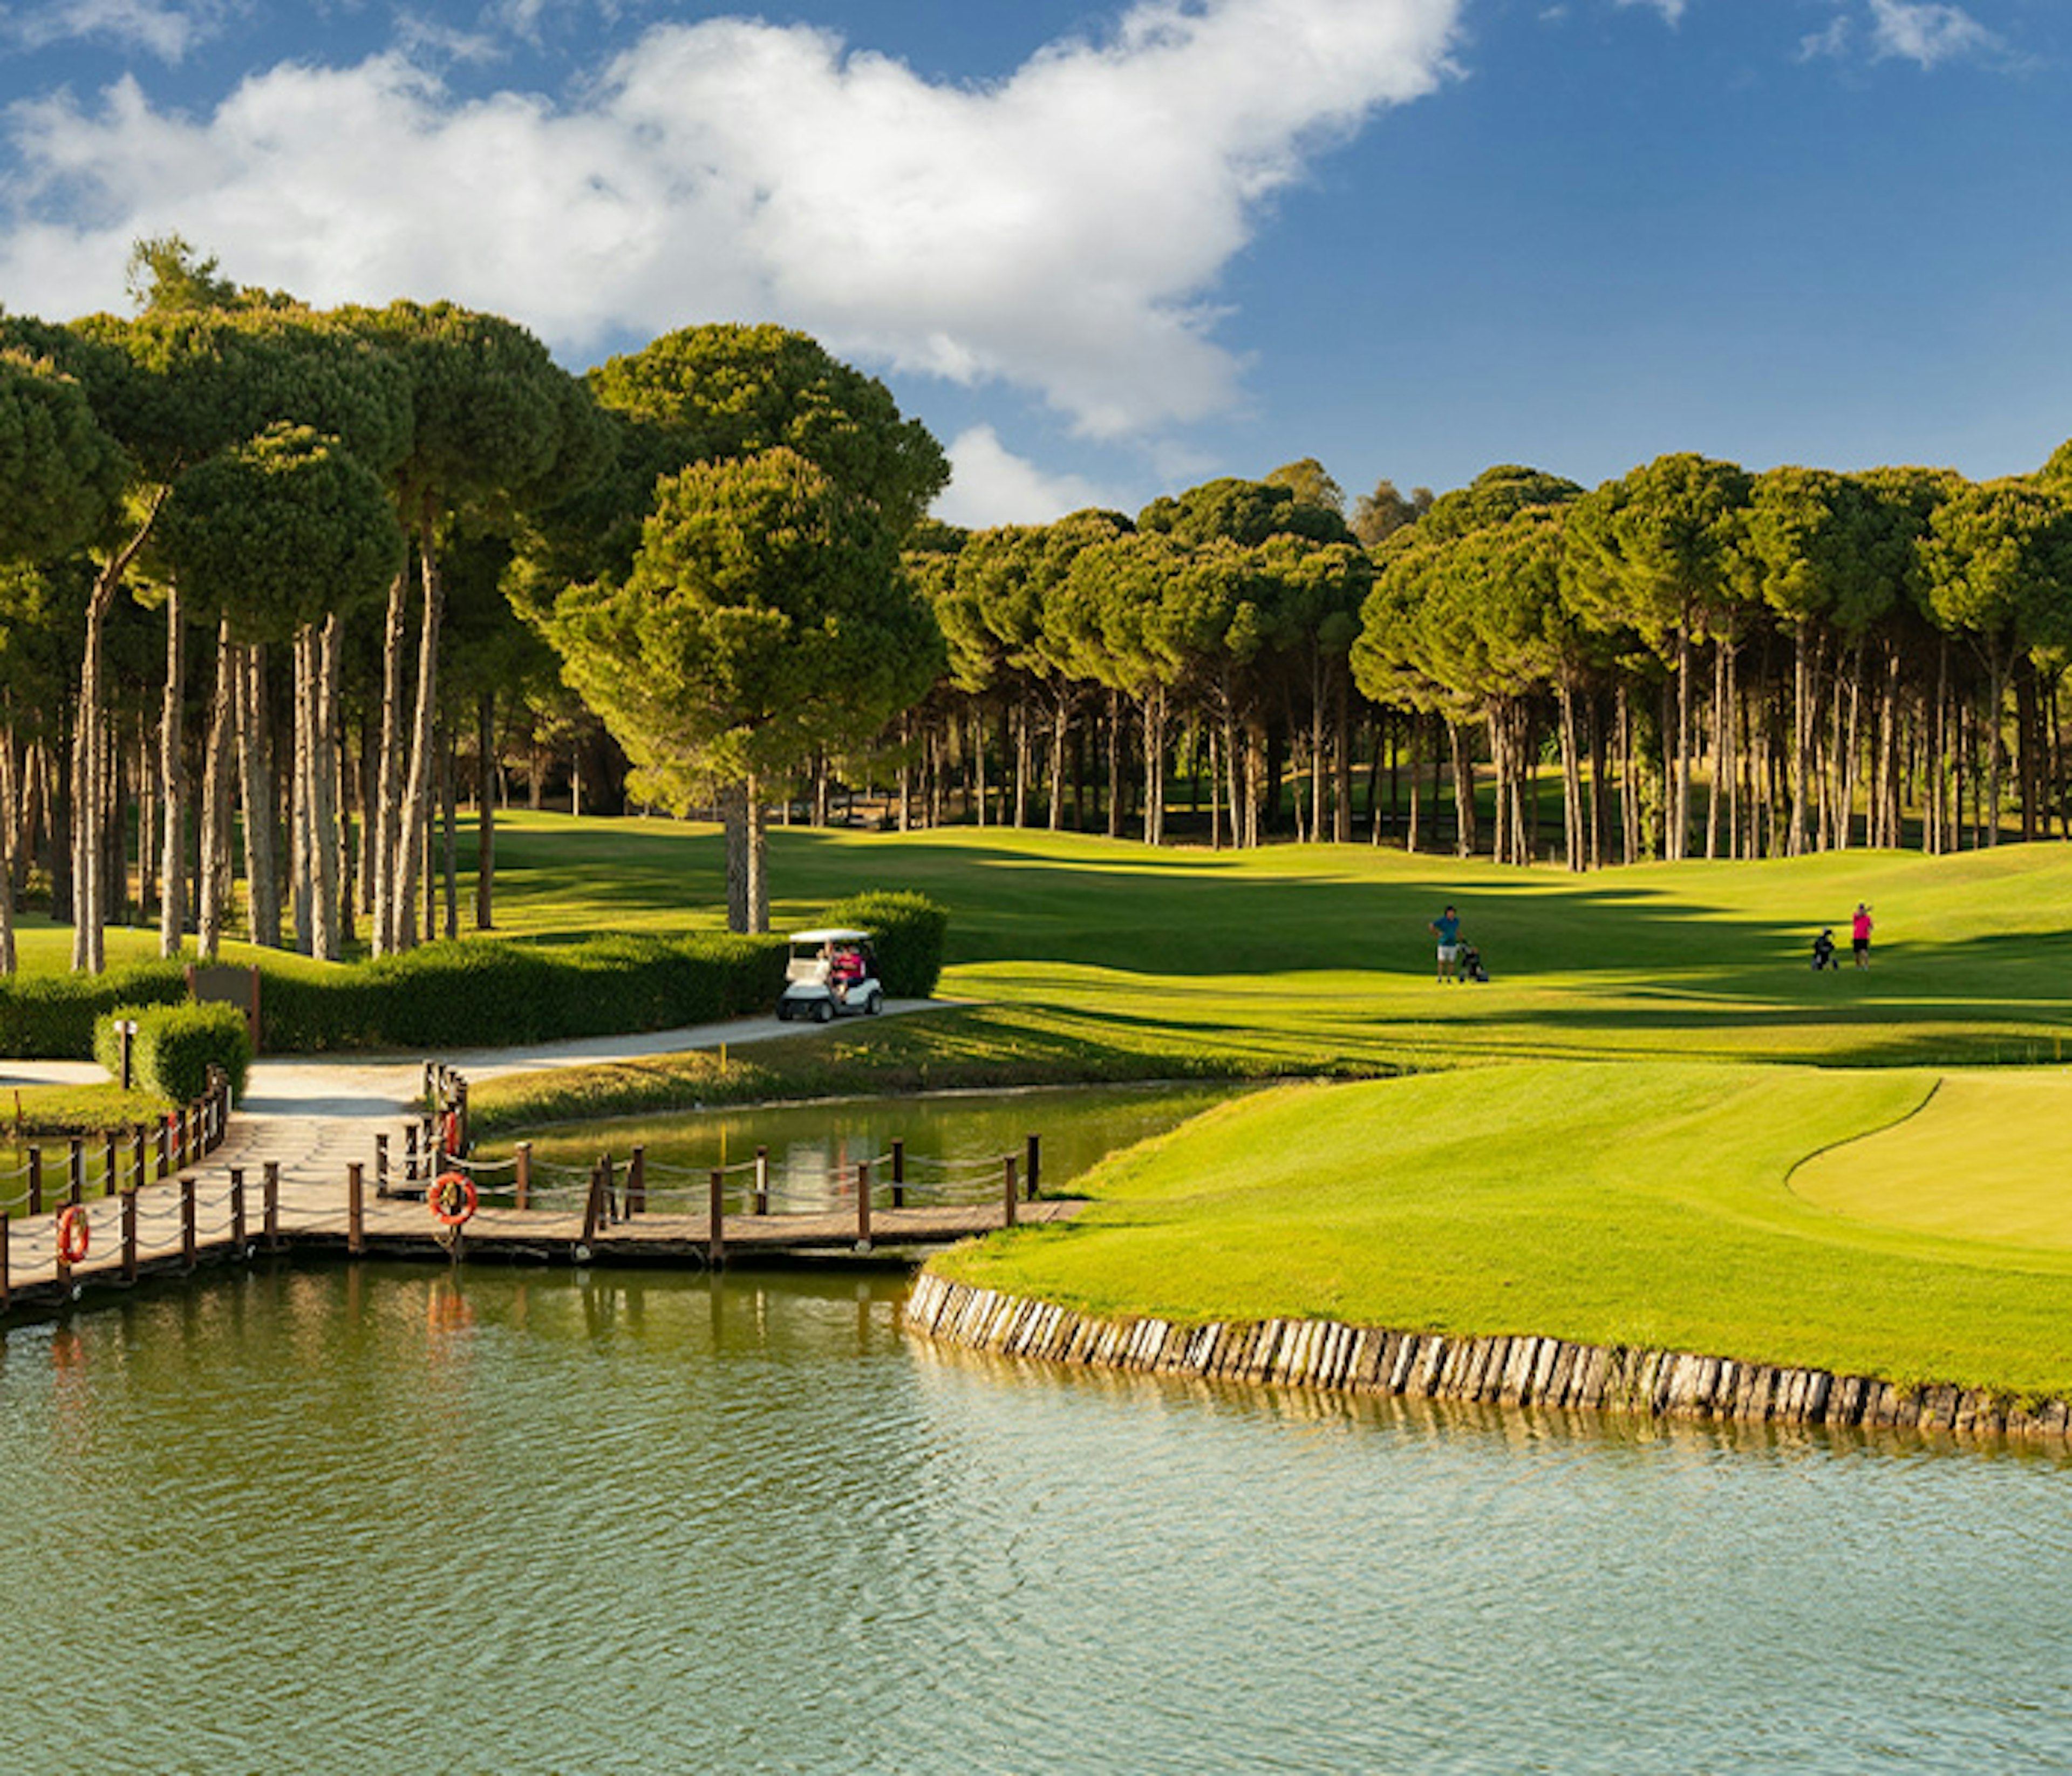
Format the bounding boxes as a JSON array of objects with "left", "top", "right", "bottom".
[{"left": 259, "top": 935, "right": 785, "bottom": 1053}]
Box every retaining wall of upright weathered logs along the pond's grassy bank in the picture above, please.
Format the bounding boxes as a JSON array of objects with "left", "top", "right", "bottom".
[{"left": 903, "top": 1273, "right": 2072, "bottom": 1440}]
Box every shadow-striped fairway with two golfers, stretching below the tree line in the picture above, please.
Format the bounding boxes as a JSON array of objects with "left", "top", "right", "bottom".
[{"left": 476, "top": 814, "right": 2072, "bottom": 1070}]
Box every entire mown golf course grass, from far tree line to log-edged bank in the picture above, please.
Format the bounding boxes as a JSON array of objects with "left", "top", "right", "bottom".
[{"left": 25, "top": 814, "right": 2072, "bottom": 1394}]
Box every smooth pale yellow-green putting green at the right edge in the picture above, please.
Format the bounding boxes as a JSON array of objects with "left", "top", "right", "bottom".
[{"left": 1790, "top": 1071, "right": 2072, "bottom": 1251}]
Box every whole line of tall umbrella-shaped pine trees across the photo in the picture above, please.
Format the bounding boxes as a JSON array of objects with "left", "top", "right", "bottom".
[{"left": 0, "top": 236, "right": 2072, "bottom": 970}]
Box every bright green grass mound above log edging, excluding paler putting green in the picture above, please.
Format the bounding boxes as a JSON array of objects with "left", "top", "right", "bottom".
[{"left": 935, "top": 1063, "right": 2072, "bottom": 1397}]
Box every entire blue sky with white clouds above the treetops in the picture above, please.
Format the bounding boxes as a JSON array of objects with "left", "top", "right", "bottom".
[{"left": 0, "top": 0, "right": 2072, "bottom": 522}]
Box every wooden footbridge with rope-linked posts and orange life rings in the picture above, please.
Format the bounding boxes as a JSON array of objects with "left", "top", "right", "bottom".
[{"left": 0, "top": 1070, "right": 1078, "bottom": 1312}]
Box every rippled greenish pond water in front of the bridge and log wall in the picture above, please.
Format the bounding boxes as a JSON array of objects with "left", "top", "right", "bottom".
[{"left": 0, "top": 1266, "right": 2072, "bottom": 1776}]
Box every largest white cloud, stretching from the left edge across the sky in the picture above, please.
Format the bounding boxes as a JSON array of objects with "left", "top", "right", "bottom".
[{"left": 0, "top": 0, "right": 1465, "bottom": 435}]
